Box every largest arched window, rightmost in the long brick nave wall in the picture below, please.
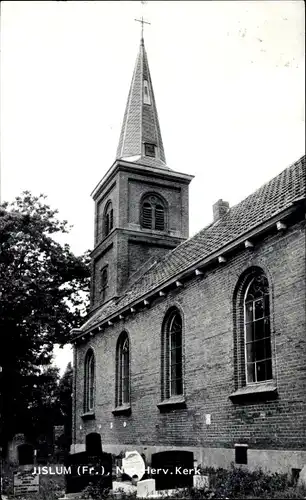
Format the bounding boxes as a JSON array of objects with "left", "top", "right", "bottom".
[{"left": 244, "top": 273, "right": 272, "bottom": 384}]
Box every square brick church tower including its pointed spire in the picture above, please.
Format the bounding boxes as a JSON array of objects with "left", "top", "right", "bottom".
[{"left": 91, "top": 33, "right": 193, "bottom": 311}]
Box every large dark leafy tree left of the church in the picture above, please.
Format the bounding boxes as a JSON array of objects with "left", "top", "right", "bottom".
[{"left": 0, "top": 192, "right": 90, "bottom": 448}]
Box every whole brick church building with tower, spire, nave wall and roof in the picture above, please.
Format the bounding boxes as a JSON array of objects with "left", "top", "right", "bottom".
[{"left": 71, "top": 35, "right": 306, "bottom": 471}]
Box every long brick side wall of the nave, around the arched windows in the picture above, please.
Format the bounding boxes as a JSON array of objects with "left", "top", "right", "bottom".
[{"left": 75, "top": 221, "right": 306, "bottom": 458}]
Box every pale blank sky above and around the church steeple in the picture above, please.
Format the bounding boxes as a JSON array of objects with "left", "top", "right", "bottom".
[{"left": 1, "top": 0, "right": 305, "bottom": 376}]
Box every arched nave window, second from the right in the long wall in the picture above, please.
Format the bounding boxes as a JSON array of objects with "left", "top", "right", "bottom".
[{"left": 162, "top": 309, "right": 184, "bottom": 399}]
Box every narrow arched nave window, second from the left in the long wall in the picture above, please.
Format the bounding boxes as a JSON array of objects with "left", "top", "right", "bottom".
[{"left": 116, "top": 332, "right": 130, "bottom": 407}]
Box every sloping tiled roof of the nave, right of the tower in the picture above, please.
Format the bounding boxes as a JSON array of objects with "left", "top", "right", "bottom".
[{"left": 77, "top": 156, "right": 306, "bottom": 331}]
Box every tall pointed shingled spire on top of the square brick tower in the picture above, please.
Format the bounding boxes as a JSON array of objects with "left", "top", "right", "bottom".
[{"left": 116, "top": 38, "right": 168, "bottom": 168}]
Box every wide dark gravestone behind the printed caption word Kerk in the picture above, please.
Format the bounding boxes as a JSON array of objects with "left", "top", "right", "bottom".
[{"left": 151, "top": 450, "right": 194, "bottom": 491}]
